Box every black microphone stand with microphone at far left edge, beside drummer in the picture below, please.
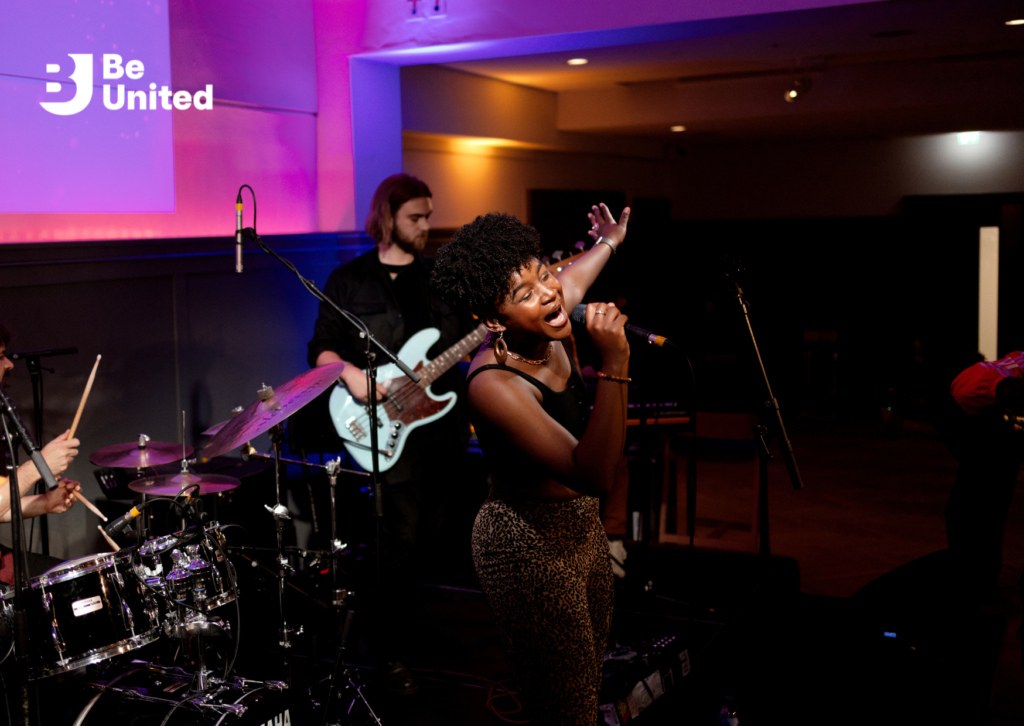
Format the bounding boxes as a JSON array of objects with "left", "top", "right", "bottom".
[{"left": 0, "top": 386, "right": 56, "bottom": 726}]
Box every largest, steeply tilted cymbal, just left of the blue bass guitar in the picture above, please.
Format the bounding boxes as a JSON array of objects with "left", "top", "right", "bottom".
[{"left": 203, "top": 362, "right": 345, "bottom": 459}]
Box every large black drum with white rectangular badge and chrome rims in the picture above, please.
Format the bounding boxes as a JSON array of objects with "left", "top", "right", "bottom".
[{"left": 3, "top": 553, "right": 160, "bottom": 678}]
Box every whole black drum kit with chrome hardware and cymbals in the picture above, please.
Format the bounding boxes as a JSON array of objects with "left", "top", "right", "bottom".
[{"left": 0, "top": 364, "right": 380, "bottom": 726}]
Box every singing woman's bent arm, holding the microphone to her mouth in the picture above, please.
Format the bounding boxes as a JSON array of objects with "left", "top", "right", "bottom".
[{"left": 469, "top": 303, "right": 630, "bottom": 495}]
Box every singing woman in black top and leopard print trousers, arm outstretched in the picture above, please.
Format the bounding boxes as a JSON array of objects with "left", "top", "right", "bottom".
[{"left": 433, "top": 204, "right": 630, "bottom": 726}]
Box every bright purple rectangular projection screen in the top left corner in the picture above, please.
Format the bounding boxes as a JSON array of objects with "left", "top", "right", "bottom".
[{"left": 0, "top": 0, "right": 177, "bottom": 213}]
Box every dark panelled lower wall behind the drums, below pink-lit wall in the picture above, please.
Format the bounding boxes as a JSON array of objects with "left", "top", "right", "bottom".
[{"left": 0, "top": 233, "right": 370, "bottom": 557}]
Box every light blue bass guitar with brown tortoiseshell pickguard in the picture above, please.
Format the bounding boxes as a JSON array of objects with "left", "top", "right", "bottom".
[{"left": 330, "top": 325, "right": 487, "bottom": 471}]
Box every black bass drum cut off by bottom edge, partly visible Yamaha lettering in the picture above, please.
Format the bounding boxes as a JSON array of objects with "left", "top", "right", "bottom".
[{"left": 73, "top": 668, "right": 299, "bottom": 726}]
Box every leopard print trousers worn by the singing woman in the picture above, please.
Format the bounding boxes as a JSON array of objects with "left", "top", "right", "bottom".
[{"left": 472, "top": 496, "right": 612, "bottom": 726}]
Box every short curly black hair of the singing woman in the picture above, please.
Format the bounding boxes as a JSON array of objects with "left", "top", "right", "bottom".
[{"left": 430, "top": 212, "right": 541, "bottom": 317}]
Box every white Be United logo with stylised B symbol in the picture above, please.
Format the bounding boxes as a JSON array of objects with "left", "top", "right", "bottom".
[{"left": 39, "top": 53, "right": 213, "bottom": 116}]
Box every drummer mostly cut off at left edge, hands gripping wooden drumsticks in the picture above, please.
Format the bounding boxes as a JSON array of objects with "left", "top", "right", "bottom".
[{"left": 0, "top": 324, "right": 82, "bottom": 585}]
